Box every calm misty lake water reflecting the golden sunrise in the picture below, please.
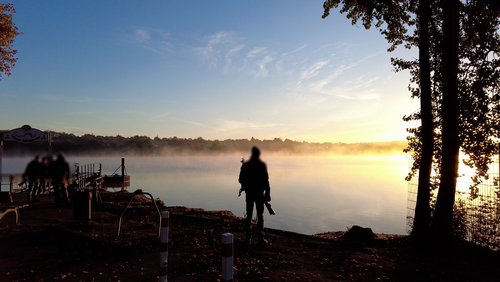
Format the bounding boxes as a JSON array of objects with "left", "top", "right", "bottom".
[{"left": 2, "top": 153, "right": 409, "bottom": 234}]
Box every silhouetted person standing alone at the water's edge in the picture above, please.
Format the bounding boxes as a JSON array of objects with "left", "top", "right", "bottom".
[{"left": 238, "top": 147, "right": 271, "bottom": 244}]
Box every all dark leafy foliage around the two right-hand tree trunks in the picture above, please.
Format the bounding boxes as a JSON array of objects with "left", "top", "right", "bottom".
[{"left": 323, "top": 0, "right": 500, "bottom": 239}]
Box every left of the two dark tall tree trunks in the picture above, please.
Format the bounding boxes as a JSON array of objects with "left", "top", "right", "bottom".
[{"left": 412, "top": 0, "right": 434, "bottom": 238}]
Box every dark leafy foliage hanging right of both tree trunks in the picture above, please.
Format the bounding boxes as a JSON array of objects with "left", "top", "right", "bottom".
[{"left": 458, "top": 0, "right": 500, "bottom": 195}]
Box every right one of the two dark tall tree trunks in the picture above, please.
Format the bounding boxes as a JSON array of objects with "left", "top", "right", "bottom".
[{"left": 432, "top": 0, "right": 460, "bottom": 239}]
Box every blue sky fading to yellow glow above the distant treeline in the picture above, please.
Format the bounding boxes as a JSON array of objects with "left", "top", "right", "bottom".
[{"left": 0, "top": 0, "right": 418, "bottom": 143}]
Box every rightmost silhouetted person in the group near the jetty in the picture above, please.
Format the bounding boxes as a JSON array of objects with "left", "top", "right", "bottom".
[{"left": 50, "top": 154, "right": 70, "bottom": 204}]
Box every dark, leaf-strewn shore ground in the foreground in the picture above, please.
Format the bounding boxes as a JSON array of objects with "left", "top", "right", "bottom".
[{"left": 0, "top": 191, "right": 500, "bottom": 281}]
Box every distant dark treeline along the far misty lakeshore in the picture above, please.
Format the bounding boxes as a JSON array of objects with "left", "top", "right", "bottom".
[{"left": 3, "top": 133, "right": 406, "bottom": 156}]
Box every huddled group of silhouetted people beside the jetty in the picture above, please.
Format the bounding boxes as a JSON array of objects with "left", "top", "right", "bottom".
[{"left": 19, "top": 154, "right": 70, "bottom": 204}]
